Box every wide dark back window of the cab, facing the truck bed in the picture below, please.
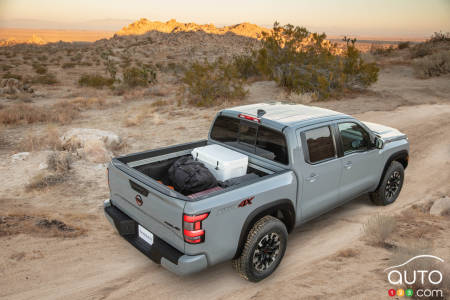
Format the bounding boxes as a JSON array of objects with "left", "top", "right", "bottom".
[{"left": 211, "top": 116, "right": 289, "bottom": 164}]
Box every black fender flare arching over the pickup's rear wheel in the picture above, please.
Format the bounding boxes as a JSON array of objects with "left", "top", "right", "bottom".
[{"left": 233, "top": 199, "right": 295, "bottom": 259}]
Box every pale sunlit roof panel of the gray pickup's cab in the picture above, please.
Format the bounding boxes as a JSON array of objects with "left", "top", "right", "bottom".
[{"left": 222, "top": 102, "right": 350, "bottom": 128}]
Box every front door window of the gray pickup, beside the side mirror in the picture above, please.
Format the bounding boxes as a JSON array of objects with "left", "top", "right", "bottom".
[{"left": 338, "top": 123, "right": 370, "bottom": 155}]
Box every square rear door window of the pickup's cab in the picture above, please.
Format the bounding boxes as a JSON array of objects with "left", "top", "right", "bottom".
[{"left": 304, "top": 126, "right": 336, "bottom": 163}]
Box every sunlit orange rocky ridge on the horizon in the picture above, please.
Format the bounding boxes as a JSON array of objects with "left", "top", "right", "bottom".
[{"left": 117, "top": 18, "right": 271, "bottom": 39}]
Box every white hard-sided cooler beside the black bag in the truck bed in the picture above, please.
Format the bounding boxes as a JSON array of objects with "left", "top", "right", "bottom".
[{"left": 191, "top": 145, "right": 248, "bottom": 181}]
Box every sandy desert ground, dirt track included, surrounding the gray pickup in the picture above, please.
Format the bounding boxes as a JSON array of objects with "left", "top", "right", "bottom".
[{"left": 0, "top": 19, "right": 450, "bottom": 299}]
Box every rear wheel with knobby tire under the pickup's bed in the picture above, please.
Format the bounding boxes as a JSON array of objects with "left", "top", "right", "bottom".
[{"left": 232, "top": 216, "right": 288, "bottom": 282}]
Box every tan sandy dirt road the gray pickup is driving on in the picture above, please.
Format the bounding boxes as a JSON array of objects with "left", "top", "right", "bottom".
[{"left": 0, "top": 104, "right": 450, "bottom": 299}]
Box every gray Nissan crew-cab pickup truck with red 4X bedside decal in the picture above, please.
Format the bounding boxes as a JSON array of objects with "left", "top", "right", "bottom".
[{"left": 104, "top": 103, "right": 409, "bottom": 282}]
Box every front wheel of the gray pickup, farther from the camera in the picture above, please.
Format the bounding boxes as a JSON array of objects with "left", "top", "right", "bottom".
[{"left": 370, "top": 161, "right": 405, "bottom": 205}]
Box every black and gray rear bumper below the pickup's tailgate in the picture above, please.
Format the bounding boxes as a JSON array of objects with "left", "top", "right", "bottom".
[{"left": 103, "top": 200, "right": 208, "bottom": 275}]
